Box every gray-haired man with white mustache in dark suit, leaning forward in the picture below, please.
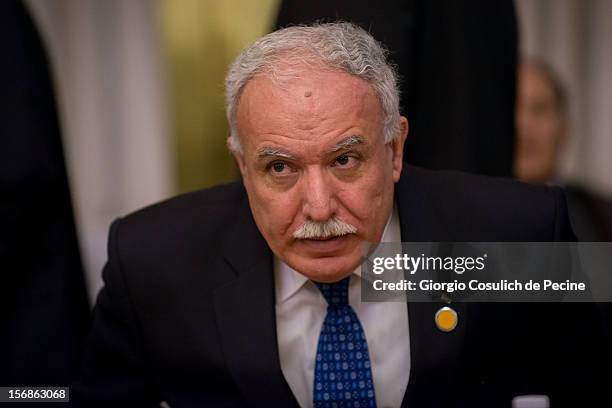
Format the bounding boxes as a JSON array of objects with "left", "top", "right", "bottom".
[{"left": 73, "top": 23, "right": 599, "bottom": 407}]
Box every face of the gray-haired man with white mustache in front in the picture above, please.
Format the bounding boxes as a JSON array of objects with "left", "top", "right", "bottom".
[{"left": 235, "top": 69, "right": 407, "bottom": 282}]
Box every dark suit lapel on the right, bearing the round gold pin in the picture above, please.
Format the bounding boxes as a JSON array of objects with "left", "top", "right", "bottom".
[{"left": 396, "top": 166, "right": 467, "bottom": 407}]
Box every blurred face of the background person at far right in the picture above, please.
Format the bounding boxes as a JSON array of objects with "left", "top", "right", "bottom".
[{"left": 514, "top": 65, "right": 564, "bottom": 183}]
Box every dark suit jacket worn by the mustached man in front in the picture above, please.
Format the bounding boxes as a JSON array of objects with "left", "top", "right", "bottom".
[{"left": 72, "top": 167, "right": 600, "bottom": 407}]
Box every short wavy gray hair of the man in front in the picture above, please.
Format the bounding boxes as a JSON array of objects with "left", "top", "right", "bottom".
[{"left": 225, "top": 22, "right": 400, "bottom": 153}]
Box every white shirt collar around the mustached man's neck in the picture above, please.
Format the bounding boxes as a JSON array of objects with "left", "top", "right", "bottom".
[{"left": 274, "top": 207, "right": 402, "bottom": 304}]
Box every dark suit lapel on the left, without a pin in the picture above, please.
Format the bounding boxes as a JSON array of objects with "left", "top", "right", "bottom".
[{"left": 214, "top": 196, "right": 297, "bottom": 406}]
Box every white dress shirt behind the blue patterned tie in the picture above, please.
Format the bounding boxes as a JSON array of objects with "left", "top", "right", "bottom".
[{"left": 274, "top": 209, "right": 410, "bottom": 408}]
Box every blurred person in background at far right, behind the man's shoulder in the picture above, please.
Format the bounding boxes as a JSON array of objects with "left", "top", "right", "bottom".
[{"left": 514, "top": 60, "right": 612, "bottom": 241}]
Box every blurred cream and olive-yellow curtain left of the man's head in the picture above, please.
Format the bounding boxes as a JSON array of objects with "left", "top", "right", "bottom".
[{"left": 26, "top": 0, "right": 278, "bottom": 299}]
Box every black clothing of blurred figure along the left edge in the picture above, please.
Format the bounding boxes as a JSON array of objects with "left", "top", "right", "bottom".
[{"left": 0, "top": 1, "right": 89, "bottom": 386}]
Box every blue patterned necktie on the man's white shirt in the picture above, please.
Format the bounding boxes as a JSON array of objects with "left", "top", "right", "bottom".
[{"left": 313, "top": 277, "right": 376, "bottom": 408}]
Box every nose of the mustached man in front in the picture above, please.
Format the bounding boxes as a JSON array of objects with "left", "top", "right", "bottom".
[{"left": 303, "top": 169, "right": 336, "bottom": 221}]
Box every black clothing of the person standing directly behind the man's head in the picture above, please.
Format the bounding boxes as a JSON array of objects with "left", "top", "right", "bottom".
[{"left": 277, "top": 0, "right": 517, "bottom": 177}]
